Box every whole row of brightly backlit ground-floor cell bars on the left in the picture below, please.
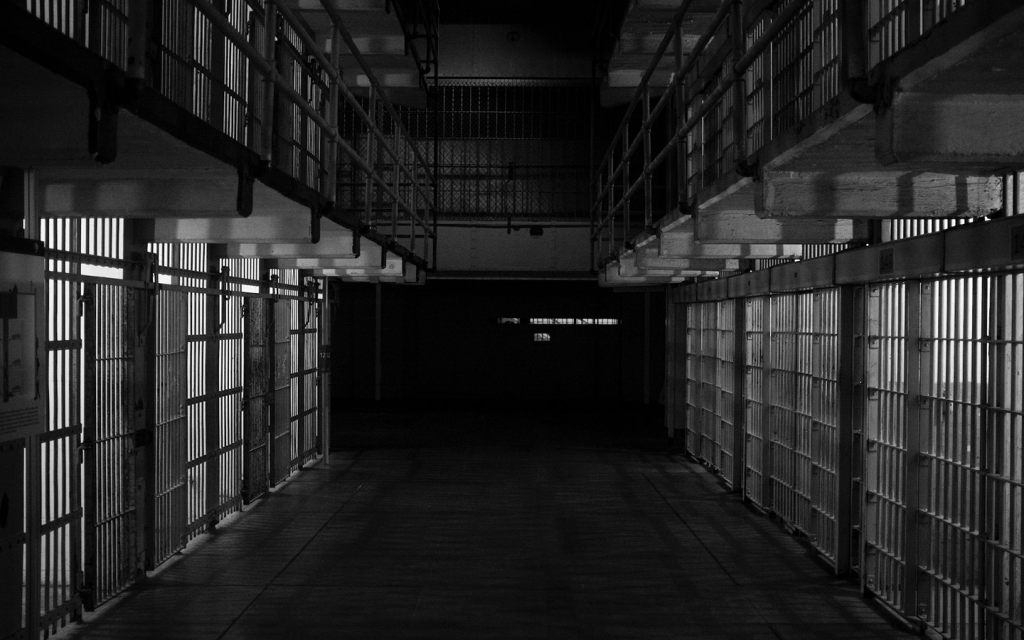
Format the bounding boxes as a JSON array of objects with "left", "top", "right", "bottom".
[{"left": 25, "top": 219, "right": 321, "bottom": 634}]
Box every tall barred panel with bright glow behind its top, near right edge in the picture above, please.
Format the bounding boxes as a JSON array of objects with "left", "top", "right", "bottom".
[{"left": 909, "top": 278, "right": 989, "bottom": 638}]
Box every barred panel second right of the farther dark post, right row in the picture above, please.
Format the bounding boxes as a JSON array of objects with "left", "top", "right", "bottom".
[{"left": 769, "top": 294, "right": 811, "bottom": 531}]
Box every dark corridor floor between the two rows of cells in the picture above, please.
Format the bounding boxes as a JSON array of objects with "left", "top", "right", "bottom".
[{"left": 60, "top": 411, "right": 915, "bottom": 640}]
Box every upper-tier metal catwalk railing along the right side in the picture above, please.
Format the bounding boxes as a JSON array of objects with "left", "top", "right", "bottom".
[{"left": 591, "top": 0, "right": 968, "bottom": 262}]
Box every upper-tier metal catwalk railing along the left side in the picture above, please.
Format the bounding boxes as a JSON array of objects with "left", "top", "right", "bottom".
[{"left": 12, "top": 0, "right": 436, "bottom": 261}]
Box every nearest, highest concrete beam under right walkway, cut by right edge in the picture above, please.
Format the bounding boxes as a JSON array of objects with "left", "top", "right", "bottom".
[{"left": 876, "top": 93, "right": 1024, "bottom": 169}]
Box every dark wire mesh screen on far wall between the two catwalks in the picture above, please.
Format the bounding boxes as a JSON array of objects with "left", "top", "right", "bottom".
[{"left": 406, "top": 79, "right": 595, "bottom": 220}]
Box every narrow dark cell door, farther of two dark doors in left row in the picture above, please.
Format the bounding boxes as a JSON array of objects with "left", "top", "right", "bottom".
[{"left": 242, "top": 298, "right": 273, "bottom": 504}]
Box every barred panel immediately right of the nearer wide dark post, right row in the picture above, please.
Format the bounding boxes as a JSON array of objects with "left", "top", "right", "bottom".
[{"left": 861, "top": 283, "right": 908, "bottom": 609}]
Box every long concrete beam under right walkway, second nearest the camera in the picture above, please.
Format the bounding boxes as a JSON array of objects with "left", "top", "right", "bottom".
[{"left": 755, "top": 171, "right": 1002, "bottom": 222}]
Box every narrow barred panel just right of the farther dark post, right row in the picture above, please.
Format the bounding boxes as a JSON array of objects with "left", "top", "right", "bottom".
[{"left": 743, "top": 297, "right": 771, "bottom": 509}]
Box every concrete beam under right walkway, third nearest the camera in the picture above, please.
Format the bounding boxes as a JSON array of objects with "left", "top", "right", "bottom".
[{"left": 693, "top": 209, "right": 870, "bottom": 245}]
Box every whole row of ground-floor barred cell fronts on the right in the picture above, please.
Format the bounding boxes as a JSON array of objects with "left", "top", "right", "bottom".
[{"left": 684, "top": 272, "right": 1024, "bottom": 640}]
